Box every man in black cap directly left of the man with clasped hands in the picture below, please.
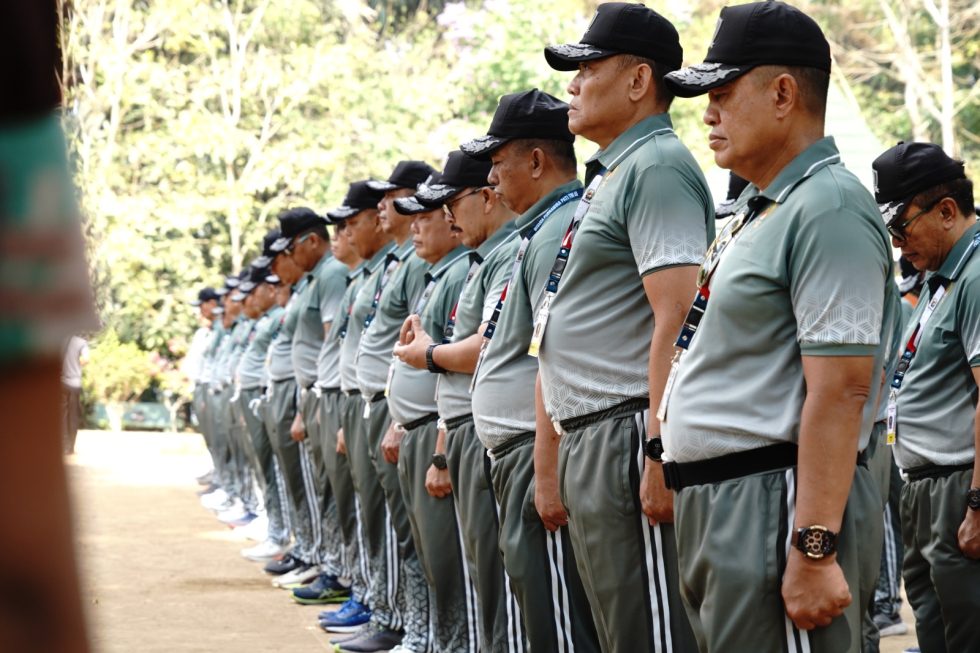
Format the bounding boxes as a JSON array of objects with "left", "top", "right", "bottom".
[{"left": 380, "top": 186, "right": 478, "bottom": 651}]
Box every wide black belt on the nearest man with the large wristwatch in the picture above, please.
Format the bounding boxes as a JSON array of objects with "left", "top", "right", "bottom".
[{"left": 664, "top": 442, "right": 868, "bottom": 491}]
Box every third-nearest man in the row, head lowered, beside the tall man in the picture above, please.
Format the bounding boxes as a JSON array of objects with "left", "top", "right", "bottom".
[{"left": 460, "top": 89, "right": 599, "bottom": 651}]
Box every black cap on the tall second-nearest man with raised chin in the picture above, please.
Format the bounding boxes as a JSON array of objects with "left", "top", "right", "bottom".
[{"left": 544, "top": 2, "right": 684, "bottom": 70}]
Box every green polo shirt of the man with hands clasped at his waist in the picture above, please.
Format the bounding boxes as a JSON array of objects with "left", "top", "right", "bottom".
[{"left": 436, "top": 221, "right": 520, "bottom": 419}]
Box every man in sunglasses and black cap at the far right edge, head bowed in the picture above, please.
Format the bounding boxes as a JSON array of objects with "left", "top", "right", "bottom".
[{"left": 872, "top": 143, "right": 980, "bottom": 651}]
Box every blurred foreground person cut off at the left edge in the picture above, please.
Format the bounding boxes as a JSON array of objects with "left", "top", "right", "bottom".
[{"left": 0, "top": 0, "right": 97, "bottom": 653}]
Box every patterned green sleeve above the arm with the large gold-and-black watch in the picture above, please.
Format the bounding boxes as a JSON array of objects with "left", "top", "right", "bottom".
[{"left": 788, "top": 208, "right": 891, "bottom": 356}]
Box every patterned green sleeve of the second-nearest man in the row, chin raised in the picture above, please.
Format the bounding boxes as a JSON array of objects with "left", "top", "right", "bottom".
[{"left": 626, "top": 165, "right": 713, "bottom": 276}]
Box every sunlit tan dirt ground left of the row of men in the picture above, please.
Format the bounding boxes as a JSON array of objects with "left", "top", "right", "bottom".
[{"left": 68, "top": 431, "right": 915, "bottom": 653}]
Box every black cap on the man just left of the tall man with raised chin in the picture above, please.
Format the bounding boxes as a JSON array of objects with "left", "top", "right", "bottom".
[{"left": 459, "top": 88, "right": 575, "bottom": 159}]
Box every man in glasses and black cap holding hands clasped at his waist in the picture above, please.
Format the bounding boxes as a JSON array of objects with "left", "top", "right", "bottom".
[{"left": 395, "top": 150, "right": 523, "bottom": 653}]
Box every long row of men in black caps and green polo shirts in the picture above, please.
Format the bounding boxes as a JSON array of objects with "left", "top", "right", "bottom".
[{"left": 186, "top": 2, "right": 980, "bottom": 653}]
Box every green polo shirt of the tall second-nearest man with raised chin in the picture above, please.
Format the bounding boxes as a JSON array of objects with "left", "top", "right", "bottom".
[{"left": 540, "top": 114, "right": 715, "bottom": 420}]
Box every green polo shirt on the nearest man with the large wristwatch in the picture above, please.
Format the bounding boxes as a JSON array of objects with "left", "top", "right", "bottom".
[{"left": 663, "top": 137, "right": 898, "bottom": 462}]
